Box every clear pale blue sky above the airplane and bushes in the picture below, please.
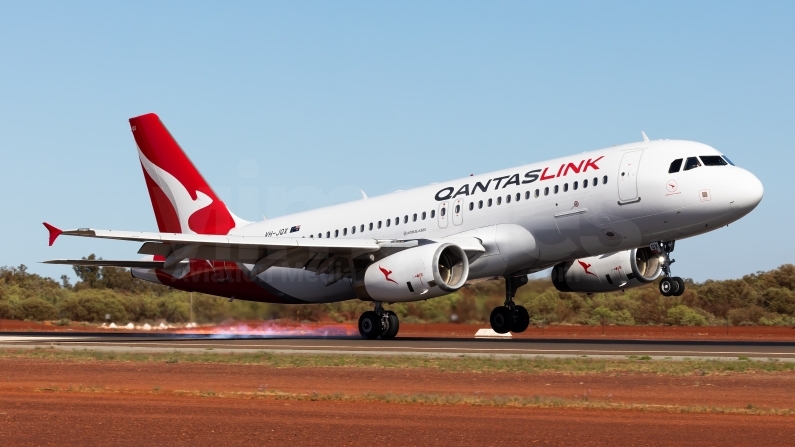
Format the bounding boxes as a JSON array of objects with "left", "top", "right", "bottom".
[{"left": 0, "top": 1, "right": 795, "bottom": 281}]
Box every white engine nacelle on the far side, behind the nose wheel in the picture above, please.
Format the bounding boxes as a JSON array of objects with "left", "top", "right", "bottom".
[{"left": 552, "top": 247, "right": 662, "bottom": 293}]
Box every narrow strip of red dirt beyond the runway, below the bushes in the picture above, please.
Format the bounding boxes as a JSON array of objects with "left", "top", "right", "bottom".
[{"left": 0, "top": 320, "right": 795, "bottom": 341}]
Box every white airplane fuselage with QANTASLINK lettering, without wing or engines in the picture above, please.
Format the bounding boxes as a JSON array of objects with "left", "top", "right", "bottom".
[{"left": 222, "top": 140, "right": 763, "bottom": 302}]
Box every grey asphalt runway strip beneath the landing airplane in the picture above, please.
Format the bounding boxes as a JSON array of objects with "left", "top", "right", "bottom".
[{"left": 0, "top": 332, "right": 795, "bottom": 361}]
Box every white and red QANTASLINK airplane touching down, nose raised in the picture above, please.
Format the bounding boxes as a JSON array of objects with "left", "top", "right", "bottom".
[{"left": 44, "top": 113, "right": 764, "bottom": 339}]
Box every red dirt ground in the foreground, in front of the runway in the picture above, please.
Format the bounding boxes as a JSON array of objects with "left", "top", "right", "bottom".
[{"left": 0, "top": 358, "right": 795, "bottom": 446}]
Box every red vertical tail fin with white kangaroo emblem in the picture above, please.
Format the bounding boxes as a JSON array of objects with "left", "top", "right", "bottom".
[{"left": 130, "top": 113, "right": 235, "bottom": 234}]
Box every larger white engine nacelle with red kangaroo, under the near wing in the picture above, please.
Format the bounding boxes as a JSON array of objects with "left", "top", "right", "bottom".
[{"left": 354, "top": 242, "right": 469, "bottom": 303}]
